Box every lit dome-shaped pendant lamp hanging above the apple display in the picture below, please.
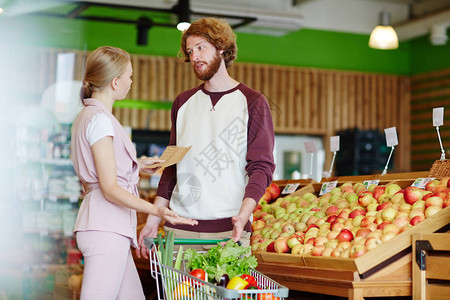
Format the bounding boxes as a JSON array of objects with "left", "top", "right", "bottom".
[{"left": 369, "top": 11, "right": 398, "bottom": 50}]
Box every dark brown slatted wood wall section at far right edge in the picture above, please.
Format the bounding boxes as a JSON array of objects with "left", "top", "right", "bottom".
[{"left": 410, "top": 69, "right": 450, "bottom": 170}]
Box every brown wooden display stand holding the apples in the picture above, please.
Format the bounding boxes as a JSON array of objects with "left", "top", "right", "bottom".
[{"left": 254, "top": 172, "right": 450, "bottom": 299}]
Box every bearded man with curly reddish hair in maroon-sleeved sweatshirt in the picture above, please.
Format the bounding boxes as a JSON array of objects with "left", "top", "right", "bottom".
[{"left": 137, "top": 18, "right": 275, "bottom": 257}]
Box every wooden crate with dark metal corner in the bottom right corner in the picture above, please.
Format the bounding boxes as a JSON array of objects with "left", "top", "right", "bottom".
[{"left": 412, "top": 232, "right": 450, "bottom": 300}]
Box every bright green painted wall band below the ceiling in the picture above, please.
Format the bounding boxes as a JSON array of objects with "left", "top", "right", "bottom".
[{"left": 0, "top": 16, "right": 450, "bottom": 75}]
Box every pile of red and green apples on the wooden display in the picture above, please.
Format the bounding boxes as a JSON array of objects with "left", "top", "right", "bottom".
[{"left": 250, "top": 177, "right": 450, "bottom": 258}]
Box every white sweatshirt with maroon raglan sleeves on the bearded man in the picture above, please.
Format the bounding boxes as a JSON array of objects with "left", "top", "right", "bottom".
[{"left": 157, "top": 83, "right": 275, "bottom": 232}]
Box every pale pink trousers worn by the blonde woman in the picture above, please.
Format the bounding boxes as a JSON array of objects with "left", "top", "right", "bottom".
[{"left": 76, "top": 231, "right": 145, "bottom": 300}]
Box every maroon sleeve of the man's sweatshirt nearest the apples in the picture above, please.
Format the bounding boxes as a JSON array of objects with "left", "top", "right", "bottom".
[{"left": 244, "top": 94, "right": 275, "bottom": 201}]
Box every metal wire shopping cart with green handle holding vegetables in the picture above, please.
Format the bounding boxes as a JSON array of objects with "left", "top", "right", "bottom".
[{"left": 144, "top": 238, "right": 289, "bottom": 300}]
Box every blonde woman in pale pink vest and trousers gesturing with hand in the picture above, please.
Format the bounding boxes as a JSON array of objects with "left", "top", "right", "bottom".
[{"left": 72, "top": 47, "right": 197, "bottom": 300}]
